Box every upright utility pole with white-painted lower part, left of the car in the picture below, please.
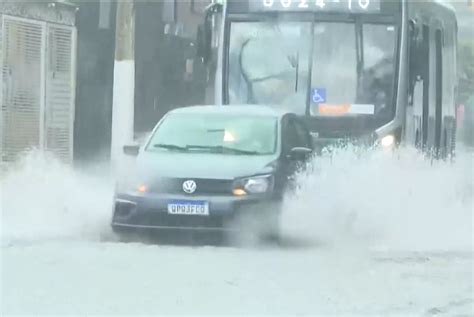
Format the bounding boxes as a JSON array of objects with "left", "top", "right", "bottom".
[{"left": 110, "top": 0, "right": 135, "bottom": 168}]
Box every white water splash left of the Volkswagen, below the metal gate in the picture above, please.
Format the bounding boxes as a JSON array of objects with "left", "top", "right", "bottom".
[{"left": 0, "top": 151, "right": 113, "bottom": 243}]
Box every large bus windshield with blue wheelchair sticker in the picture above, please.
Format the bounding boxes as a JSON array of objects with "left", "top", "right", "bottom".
[{"left": 228, "top": 21, "right": 396, "bottom": 117}]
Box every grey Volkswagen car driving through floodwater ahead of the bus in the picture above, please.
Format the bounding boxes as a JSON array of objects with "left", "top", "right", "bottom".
[{"left": 111, "top": 105, "right": 312, "bottom": 239}]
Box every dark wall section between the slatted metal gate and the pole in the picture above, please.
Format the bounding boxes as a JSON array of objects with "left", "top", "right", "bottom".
[{"left": 74, "top": 1, "right": 115, "bottom": 162}]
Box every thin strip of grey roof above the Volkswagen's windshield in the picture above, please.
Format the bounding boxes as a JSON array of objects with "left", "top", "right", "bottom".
[{"left": 169, "top": 104, "right": 289, "bottom": 118}]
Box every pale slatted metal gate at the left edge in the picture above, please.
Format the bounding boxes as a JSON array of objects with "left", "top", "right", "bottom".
[{"left": 0, "top": 14, "right": 76, "bottom": 163}]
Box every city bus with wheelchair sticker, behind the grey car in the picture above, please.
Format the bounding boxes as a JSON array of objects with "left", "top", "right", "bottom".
[{"left": 194, "top": 0, "right": 457, "bottom": 157}]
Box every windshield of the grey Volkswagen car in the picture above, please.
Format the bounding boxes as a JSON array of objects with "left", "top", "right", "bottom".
[{"left": 146, "top": 113, "right": 277, "bottom": 155}]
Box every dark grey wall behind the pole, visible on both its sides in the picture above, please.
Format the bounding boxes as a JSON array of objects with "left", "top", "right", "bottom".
[{"left": 71, "top": 0, "right": 208, "bottom": 161}]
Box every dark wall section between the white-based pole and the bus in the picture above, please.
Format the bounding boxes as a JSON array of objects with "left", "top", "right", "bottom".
[{"left": 135, "top": 1, "right": 206, "bottom": 134}]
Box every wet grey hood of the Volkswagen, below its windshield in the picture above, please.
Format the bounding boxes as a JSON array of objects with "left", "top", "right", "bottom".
[{"left": 137, "top": 151, "right": 277, "bottom": 179}]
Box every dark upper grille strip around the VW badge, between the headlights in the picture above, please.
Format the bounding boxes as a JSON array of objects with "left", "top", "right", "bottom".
[{"left": 151, "top": 178, "right": 233, "bottom": 196}]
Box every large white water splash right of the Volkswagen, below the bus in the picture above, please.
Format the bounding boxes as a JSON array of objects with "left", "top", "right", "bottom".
[{"left": 282, "top": 145, "right": 474, "bottom": 251}]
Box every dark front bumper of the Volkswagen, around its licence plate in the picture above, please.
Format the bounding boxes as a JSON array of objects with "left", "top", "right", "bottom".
[{"left": 111, "top": 190, "right": 280, "bottom": 231}]
